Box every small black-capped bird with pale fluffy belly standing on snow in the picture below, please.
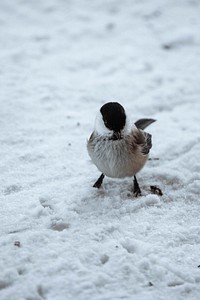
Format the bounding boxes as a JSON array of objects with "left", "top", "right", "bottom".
[{"left": 87, "top": 102, "right": 156, "bottom": 197}]
